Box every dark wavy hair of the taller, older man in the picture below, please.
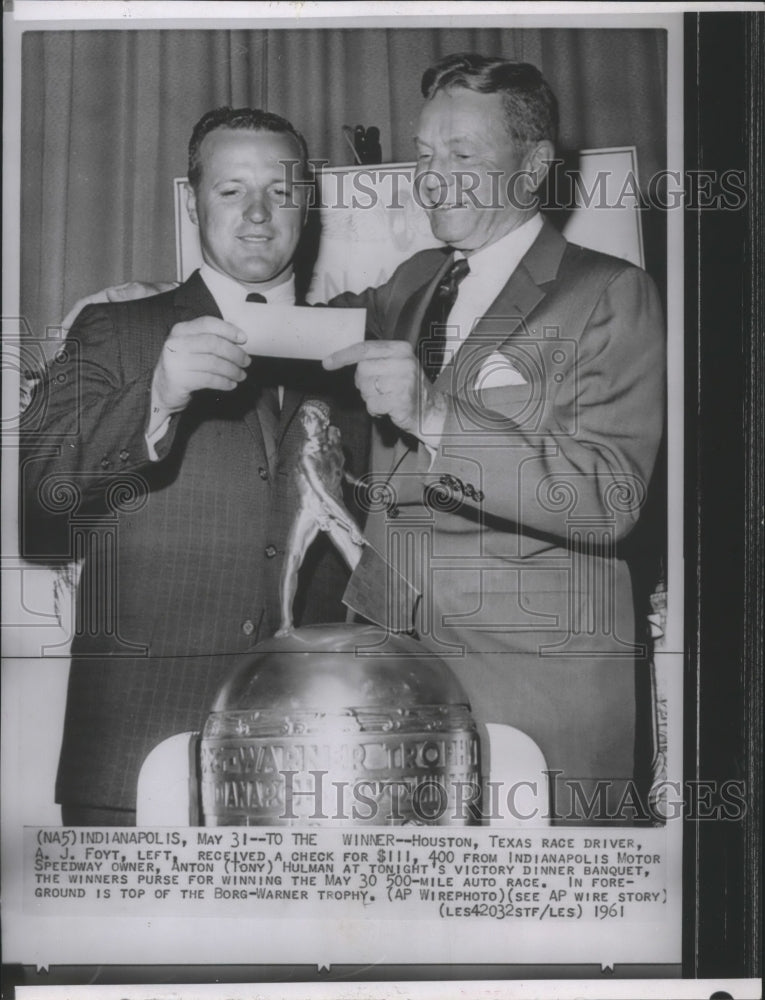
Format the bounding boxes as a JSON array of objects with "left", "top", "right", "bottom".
[{"left": 422, "top": 52, "right": 558, "bottom": 144}]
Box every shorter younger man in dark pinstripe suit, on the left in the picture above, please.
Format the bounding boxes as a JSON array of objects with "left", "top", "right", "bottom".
[{"left": 22, "top": 108, "right": 365, "bottom": 824}]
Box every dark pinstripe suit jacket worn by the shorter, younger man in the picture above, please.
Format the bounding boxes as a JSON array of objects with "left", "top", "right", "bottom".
[{"left": 22, "top": 273, "right": 366, "bottom": 809}]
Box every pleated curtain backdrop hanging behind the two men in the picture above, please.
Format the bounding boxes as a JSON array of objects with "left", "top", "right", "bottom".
[{"left": 21, "top": 28, "right": 666, "bottom": 337}]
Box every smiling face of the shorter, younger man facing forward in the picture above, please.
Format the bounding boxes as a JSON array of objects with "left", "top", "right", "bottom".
[{"left": 187, "top": 128, "right": 306, "bottom": 291}]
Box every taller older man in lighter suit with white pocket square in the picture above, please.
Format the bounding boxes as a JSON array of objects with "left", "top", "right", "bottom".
[{"left": 325, "top": 55, "right": 664, "bottom": 822}]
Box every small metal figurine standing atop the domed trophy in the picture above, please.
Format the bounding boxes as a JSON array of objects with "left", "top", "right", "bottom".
[{"left": 276, "top": 399, "right": 366, "bottom": 636}]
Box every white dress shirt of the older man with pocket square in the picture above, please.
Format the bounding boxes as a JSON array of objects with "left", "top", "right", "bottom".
[{"left": 436, "top": 212, "right": 544, "bottom": 376}]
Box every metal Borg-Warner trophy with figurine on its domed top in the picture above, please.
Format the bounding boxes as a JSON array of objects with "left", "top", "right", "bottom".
[{"left": 200, "top": 400, "right": 480, "bottom": 826}]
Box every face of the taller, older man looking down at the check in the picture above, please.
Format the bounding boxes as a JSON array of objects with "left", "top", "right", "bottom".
[{"left": 415, "top": 87, "right": 552, "bottom": 254}]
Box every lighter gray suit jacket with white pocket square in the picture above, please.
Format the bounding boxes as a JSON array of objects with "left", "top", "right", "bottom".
[{"left": 333, "top": 223, "right": 664, "bottom": 812}]
